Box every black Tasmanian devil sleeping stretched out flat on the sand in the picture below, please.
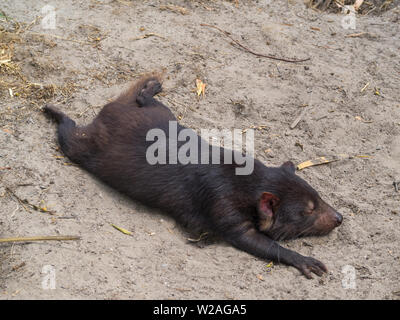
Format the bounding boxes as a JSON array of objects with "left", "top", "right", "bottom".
[{"left": 44, "top": 75, "right": 342, "bottom": 278}]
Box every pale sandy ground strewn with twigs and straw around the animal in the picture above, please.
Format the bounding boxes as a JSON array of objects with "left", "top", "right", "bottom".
[{"left": 0, "top": 0, "right": 400, "bottom": 299}]
